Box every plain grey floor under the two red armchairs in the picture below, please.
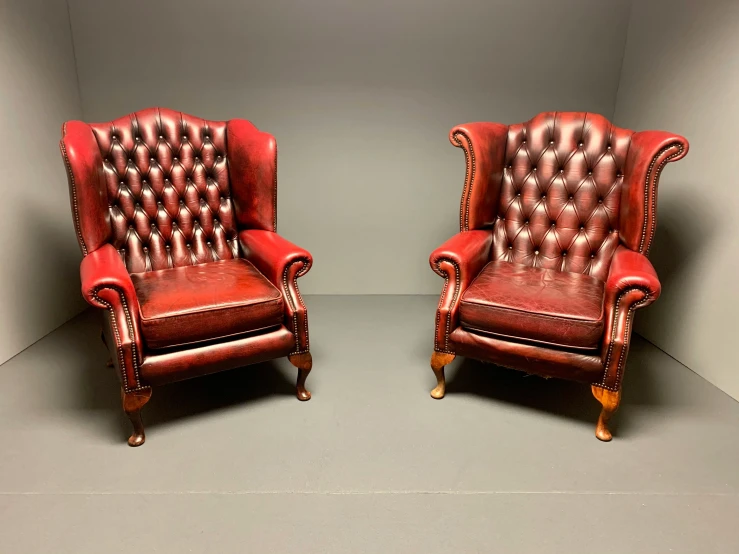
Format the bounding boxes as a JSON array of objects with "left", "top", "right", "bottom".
[{"left": 0, "top": 296, "right": 739, "bottom": 554}]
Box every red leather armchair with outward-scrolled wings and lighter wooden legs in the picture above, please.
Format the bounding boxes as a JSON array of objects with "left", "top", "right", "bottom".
[{"left": 430, "top": 112, "right": 688, "bottom": 441}]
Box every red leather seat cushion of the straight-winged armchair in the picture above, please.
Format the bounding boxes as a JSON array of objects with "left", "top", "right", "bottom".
[{"left": 131, "top": 259, "right": 285, "bottom": 349}]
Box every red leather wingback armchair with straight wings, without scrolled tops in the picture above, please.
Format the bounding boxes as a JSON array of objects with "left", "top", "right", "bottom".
[{"left": 60, "top": 108, "right": 312, "bottom": 446}]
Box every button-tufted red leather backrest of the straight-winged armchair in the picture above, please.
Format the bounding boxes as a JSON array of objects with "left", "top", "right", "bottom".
[{"left": 84, "top": 108, "right": 238, "bottom": 273}]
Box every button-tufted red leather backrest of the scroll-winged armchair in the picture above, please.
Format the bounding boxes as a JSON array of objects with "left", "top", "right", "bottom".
[{"left": 491, "top": 112, "right": 633, "bottom": 280}]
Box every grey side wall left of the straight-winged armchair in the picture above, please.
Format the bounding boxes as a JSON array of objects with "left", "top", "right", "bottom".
[{"left": 0, "top": 0, "right": 83, "bottom": 363}]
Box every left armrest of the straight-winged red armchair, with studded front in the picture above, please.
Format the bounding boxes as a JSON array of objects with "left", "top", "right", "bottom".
[{"left": 80, "top": 244, "right": 144, "bottom": 391}]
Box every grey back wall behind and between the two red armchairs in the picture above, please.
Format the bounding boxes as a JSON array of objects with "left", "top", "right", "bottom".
[{"left": 70, "top": 0, "right": 629, "bottom": 294}]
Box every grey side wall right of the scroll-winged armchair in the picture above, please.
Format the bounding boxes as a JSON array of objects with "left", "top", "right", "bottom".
[{"left": 615, "top": 0, "right": 739, "bottom": 399}]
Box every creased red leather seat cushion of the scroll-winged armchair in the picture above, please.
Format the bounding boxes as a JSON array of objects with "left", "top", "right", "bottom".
[{"left": 459, "top": 261, "right": 604, "bottom": 349}]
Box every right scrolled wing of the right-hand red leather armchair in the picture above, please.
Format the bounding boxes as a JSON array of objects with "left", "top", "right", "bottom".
[{"left": 620, "top": 131, "right": 688, "bottom": 255}]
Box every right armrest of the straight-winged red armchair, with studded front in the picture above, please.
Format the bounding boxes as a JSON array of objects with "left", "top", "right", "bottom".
[{"left": 239, "top": 229, "right": 313, "bottom": 353}]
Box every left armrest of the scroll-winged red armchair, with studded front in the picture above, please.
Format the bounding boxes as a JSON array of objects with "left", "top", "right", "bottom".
[{"left": 429, "top": 230, "right": 493, "bottom": 352}]
